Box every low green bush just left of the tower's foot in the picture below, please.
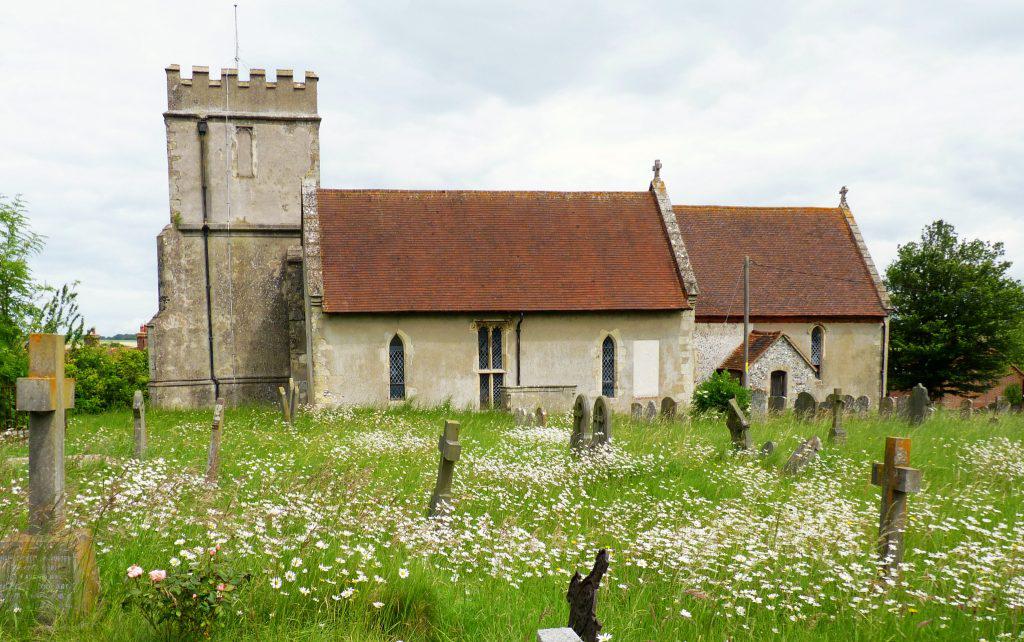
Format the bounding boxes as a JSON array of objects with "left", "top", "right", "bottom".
[{"left": 67, "top": 346, "right": 150, "bottom": 413}]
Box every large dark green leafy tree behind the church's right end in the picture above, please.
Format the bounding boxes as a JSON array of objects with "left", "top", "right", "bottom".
[{"left": 886, "top": 220, "right": 1024, "bottom": 397}]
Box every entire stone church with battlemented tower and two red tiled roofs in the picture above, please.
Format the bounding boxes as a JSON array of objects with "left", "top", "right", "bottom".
[{"left": 147, "top": 66, "right": 890, "bottom": 411}]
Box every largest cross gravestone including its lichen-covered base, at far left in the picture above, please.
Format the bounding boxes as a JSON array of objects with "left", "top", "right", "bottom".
[{"left": 0, "top": 334, "right": 99, "bottom": 623}]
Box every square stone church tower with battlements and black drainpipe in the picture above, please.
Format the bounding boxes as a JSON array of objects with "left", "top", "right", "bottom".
[{"left": 147, "top": 65, "right": 319, "bottom": 408}]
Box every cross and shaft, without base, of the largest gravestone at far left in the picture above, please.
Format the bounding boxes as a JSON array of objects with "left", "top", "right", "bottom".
[{"left": 15, "top": 334, "right": 75, "bottom": 532}]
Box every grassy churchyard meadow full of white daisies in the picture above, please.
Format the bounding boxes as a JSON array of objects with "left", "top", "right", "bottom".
[{"left": 0, "top": 408, "right": 1024, "bottom": 642}]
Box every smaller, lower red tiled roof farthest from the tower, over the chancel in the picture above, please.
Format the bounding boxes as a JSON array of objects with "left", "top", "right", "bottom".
[{"left": 673, "top": 205, "right": 886, "bottom": 317}]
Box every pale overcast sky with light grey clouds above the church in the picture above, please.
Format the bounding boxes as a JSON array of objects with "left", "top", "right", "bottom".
[{"left": 0, "top": 0, "right": 1024, "bottom": 334}]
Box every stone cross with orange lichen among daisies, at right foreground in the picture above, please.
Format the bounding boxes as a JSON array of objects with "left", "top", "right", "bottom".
[{"left": 871, "top": 437, "right": 921, "bottom": 572}]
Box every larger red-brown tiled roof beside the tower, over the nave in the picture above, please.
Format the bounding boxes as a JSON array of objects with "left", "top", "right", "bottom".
[{"left": 317, "top": 189, "right": 688, "bottom": 312}]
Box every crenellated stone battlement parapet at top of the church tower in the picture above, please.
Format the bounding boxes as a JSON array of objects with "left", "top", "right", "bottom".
[{"left": 166, "top": 65, "right": 317, "bottom": 116}]
